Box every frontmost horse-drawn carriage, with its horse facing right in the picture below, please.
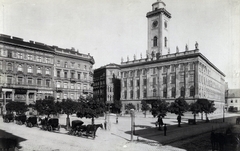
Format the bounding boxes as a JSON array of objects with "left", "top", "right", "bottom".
[{"left": 68, "top": 120, "right": 103, "bottom": 139}]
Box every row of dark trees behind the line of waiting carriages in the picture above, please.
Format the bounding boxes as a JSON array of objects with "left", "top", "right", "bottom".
[{"left": 6, "top": 96, "right": 106, "bottom": 128}]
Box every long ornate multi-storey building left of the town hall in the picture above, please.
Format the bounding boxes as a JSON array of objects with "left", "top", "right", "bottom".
[{"left": 0, "top": 34, "right": 94, "bottom": 112}]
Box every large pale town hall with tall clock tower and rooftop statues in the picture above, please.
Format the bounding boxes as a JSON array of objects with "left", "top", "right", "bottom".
[{"left": 121, "top": 1, "right": 225, "bottom": 118}]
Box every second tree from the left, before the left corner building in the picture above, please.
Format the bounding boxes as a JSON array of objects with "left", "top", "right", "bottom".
[{"left": 35, "top": 97, "right": 57, "bottom": 117}]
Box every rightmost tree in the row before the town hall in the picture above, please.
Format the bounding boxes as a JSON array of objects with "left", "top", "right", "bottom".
[{"left": 197, "top": 99, "right": 216, "bottom": 122}]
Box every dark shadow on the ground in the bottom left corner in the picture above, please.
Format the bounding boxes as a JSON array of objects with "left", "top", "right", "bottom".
[{"left": 0, "top": 129, "right": 26, "bottom": 150}]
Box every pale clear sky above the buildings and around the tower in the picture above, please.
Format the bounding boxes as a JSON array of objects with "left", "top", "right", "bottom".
[{"left": 0, "top": 0, "right": 240, "bottom": 88}]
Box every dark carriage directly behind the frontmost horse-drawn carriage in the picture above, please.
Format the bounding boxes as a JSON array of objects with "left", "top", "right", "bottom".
[{"left": 40, "top": 118, "right": 60, "bottom": 131}]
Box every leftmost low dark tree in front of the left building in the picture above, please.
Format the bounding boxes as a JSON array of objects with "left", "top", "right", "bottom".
[{"left": 6, "top": 101, "right": 28, "bottom": 114}]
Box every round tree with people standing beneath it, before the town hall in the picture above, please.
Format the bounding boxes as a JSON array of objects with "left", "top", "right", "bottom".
[{"left": 151, "top": 100, "right": 169, "bottom": 117}]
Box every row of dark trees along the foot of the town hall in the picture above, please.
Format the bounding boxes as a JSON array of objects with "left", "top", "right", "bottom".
[{"left": 141, "top": 98, "right": 216, "bottom": 120}]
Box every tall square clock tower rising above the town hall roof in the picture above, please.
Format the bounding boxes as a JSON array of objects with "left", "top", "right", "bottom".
[{"left": 146, "top": 0, "right": 171, "bottom": 57}]
